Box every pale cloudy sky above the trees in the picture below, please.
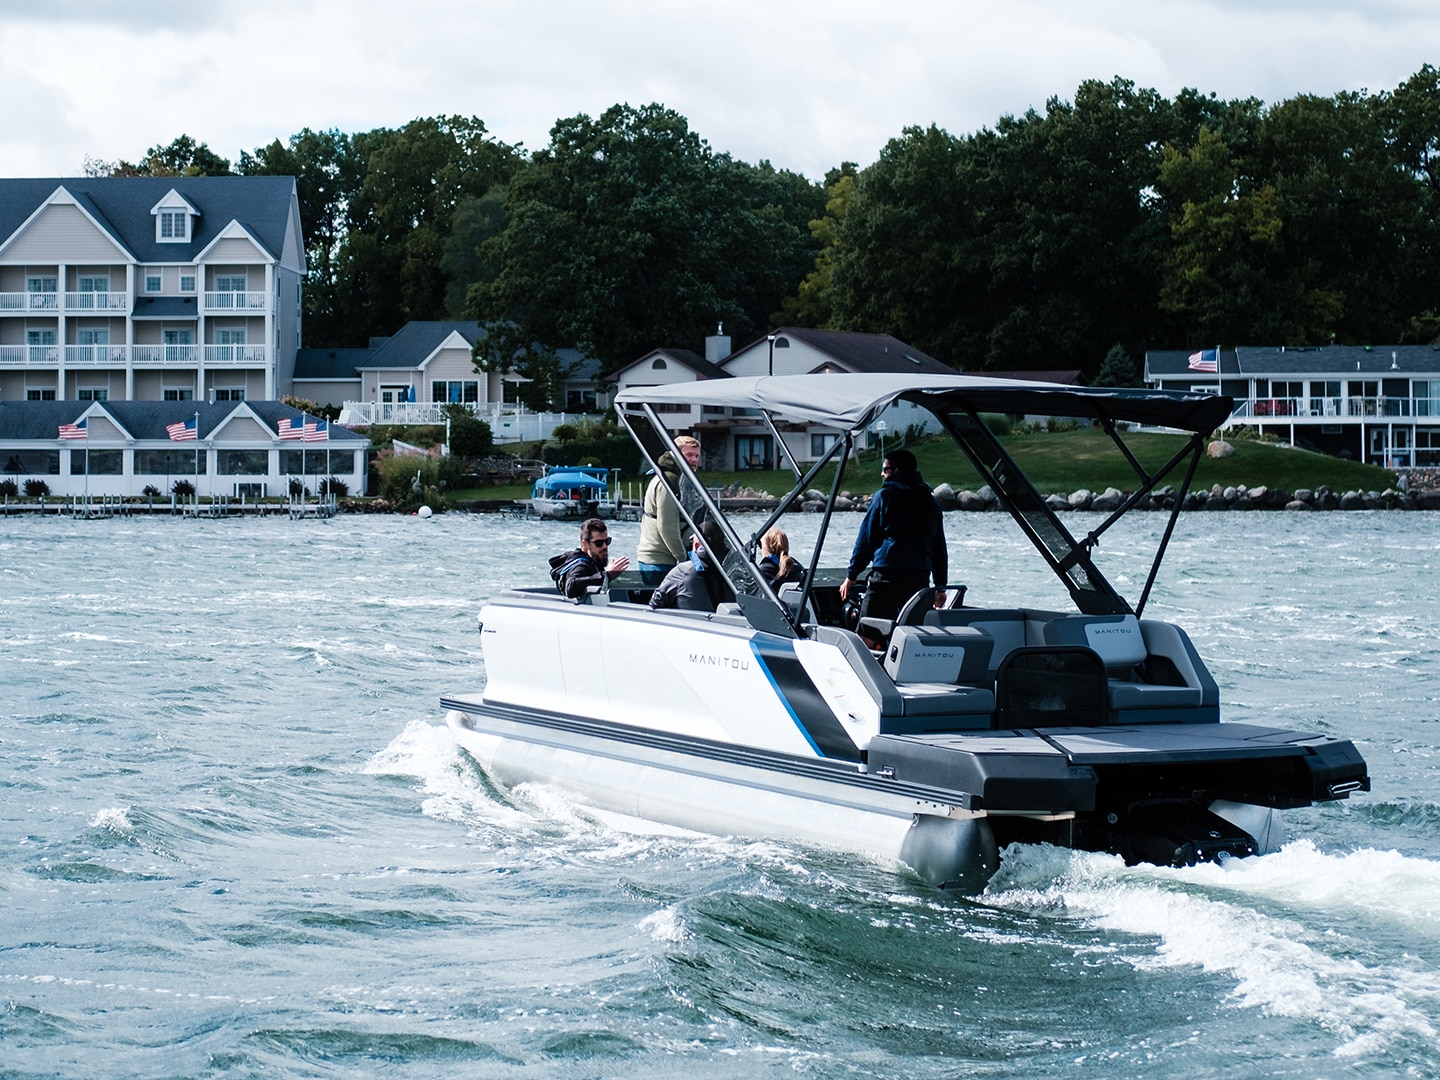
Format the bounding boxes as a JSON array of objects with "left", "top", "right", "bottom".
[{"left": 0, "top": 0, "right": 1440, "bottom": 179}]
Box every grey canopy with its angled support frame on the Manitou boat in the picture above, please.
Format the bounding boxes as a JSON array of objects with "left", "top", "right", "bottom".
[{"left": 615, "top": 374, "right": 1234, "bottom": 632}]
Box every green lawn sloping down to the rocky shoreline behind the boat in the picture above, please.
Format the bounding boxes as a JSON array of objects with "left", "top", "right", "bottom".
[{"left": 455, "top": 429, "right": 1395, "bottom": 500}]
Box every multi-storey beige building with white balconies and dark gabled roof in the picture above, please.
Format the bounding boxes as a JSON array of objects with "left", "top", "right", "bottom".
[{"left": 0, "top": 176, "right": 305, "bottom": 402}]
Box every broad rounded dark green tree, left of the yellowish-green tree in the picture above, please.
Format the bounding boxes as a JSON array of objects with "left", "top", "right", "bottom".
[{"left": 469, "top": 105, "right": 822, "bottom": 366}]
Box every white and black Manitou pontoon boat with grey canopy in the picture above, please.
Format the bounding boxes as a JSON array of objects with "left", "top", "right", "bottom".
[{"left": 442, "top": 374, "right": 1369, "bottom": 891}]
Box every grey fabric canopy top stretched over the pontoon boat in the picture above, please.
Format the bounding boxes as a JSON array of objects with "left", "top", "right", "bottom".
[{"left": 615, "top": 374, "right": 1234, "bottom": 435}]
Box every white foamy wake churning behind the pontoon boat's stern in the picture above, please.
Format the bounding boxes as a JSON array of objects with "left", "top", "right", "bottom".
[{"left": 986, "top": 841, "right": 1440, "bottom": 1058}]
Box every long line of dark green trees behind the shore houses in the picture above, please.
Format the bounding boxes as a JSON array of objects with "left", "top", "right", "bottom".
[{"left": 88, "top": 65, "right": 1440, "bottom": 397}]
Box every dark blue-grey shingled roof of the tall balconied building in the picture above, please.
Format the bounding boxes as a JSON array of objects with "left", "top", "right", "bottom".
[{"left": 0, "top": 176, "right": 295, "bottom": 269}]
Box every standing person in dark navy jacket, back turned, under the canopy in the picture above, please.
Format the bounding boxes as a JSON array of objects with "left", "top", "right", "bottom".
[{"left": 840, "top": 449, "right": 949, "bottom": 633}]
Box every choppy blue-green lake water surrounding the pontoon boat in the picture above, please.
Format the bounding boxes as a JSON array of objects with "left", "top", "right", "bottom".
[{"left": 0, "top": 513, "right": 1440, "bottom": 1077}]
